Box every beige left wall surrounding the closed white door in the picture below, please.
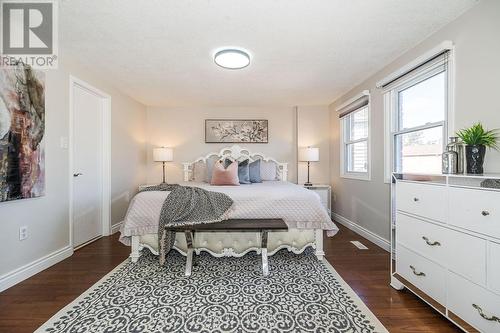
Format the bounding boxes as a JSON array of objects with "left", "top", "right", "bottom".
[{"left": 0, "top": 52, "right": 146, "bottom": 290}]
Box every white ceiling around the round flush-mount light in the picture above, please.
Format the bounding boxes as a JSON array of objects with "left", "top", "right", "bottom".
[{"left": 59, "top": 0, "right": 476, "bottom": 106}]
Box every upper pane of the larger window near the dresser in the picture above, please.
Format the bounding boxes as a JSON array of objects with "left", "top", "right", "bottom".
[{"left": 399, "top": 72, "right": 446, "bottom": 130}]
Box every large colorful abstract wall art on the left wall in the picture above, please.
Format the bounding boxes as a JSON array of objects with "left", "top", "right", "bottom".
[{"left": 0, "top": 64, "right": 45, "bottom": 202}]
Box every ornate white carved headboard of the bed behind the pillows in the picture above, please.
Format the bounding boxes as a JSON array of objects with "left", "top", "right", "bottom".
[{"left": 182, "top": 145, "right": 288, "bottom": 182}]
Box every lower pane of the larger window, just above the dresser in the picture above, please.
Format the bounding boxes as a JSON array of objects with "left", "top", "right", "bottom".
[{"left": 395, "top": 126, "right": 443, "bottom": 174}]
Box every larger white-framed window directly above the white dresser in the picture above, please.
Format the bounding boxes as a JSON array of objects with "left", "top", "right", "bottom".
[{"left": 384, "top": 46, "right": 449, "bottom": 181}]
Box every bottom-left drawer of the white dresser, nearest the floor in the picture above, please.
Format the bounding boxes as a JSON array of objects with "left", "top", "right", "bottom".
[{"left": 396, "top": 244, "right": 446, "bottom": 305}]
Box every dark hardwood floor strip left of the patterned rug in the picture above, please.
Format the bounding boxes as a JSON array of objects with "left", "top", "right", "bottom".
[{"left": 0, "top": 234, "right": 130, "bottom": 333}]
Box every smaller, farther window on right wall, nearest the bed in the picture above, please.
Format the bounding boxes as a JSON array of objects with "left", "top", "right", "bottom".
[{"left": 340, "top": 94, "right": 370, "bottom": 180}]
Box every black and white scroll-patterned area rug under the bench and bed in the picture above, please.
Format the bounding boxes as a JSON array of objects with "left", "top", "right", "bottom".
[{"left": 37, "top": 250, "right": 387, "bottom": 333}]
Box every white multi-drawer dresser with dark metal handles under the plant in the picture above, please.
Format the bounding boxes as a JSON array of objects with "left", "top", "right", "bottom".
[{"left": 391, "top": 174, "right": 500, "bottom": 333}]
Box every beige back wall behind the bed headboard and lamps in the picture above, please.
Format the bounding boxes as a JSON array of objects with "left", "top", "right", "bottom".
[{"left": 147, "top": 106, "right": 329, "bottom": 183}]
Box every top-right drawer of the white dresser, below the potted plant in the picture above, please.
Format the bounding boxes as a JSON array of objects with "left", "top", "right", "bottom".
[{"left": 448, "top": 187, "right": 500, "bottom": 238}]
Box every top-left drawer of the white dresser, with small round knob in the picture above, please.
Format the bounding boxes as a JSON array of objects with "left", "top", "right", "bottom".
[{"left": 396, "top": 181, "right": 447, "bottom": 222}]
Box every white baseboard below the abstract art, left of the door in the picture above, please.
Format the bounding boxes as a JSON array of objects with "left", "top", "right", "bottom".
[{"left": 0, "top": 245, "right": 73, "bottom": 291}]
